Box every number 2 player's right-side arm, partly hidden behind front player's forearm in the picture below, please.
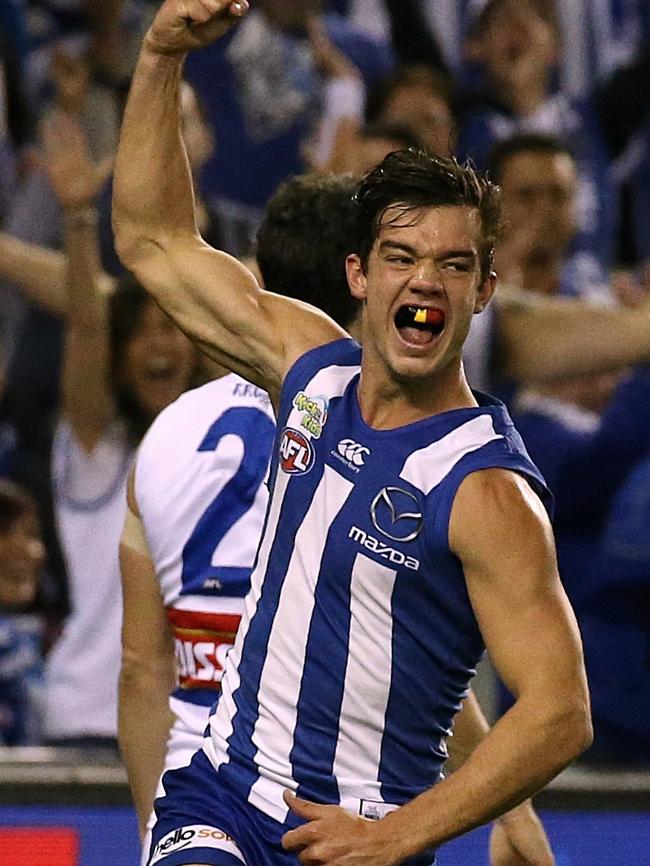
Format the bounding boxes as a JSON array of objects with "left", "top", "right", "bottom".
[{"left": 449, "top": 691, "right": 555, "bottom": 866}]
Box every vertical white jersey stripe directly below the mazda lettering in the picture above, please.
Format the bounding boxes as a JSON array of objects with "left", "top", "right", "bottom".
[{"left": 334, "top": 553, "right": 397, "bottom": 807}]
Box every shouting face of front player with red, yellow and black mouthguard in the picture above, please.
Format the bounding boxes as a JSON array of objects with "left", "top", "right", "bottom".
[{"left": 347, "top": 206, "right": 494, "bottom": 381}]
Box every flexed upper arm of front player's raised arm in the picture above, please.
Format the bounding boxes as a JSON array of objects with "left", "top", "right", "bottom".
[{"left": 126, "top": 237, "right": 346, "bottom": 393}]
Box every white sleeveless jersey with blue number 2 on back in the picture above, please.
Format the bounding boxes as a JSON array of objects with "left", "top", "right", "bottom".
[{"left": 135, "top": 374, "right": 275, "bottom": 708}]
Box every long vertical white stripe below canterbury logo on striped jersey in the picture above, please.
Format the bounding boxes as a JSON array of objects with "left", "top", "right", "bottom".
[{"left": 248, "top": 465, "right": 354, "bottom": 821}]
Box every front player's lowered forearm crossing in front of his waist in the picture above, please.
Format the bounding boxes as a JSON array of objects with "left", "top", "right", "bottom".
[{"left": 381, "top": 700, "right": 586, "bottom": 862}]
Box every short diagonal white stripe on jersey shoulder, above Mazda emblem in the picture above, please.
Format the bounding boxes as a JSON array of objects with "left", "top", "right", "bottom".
[{"left": 400, "top": 415, "right": 503, "bottom": 495}]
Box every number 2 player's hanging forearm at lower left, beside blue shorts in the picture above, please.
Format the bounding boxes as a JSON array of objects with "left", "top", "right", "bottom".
[{"left": 118, "top": 667, "right": 174, "bottom": 836}]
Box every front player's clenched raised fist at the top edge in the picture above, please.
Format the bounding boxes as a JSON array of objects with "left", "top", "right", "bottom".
[{"left": 145, "top": 0, "right": 248, "bottom": 54}]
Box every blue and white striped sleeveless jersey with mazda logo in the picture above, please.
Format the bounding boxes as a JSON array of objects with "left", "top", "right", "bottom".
[{"left": 204, "top": 340, "right": 550, "bottom": 825}]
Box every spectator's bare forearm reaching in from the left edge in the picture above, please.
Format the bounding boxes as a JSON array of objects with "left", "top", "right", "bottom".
[{"left": 0, "top": 232, "right": 67, "bottom": 316}]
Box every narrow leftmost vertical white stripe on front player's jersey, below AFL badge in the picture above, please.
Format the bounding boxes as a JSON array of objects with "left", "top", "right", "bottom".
[{"left": 203, "top": 472, "right": 290, "bottom": 770}]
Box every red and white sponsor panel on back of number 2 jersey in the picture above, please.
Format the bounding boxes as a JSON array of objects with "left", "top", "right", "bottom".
[{"left": 168, "top": 609, "right": 241, "bottom": 689}]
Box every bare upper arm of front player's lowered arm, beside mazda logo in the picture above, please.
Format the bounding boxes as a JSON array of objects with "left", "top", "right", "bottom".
[{"left": 450, "top": 469, "right": 585, "bottom": 697}]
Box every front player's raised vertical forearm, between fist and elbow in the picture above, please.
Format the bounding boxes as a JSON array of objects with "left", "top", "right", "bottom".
[{"left": 113, "top": 45, "right": 196, "bottom": 266}]
